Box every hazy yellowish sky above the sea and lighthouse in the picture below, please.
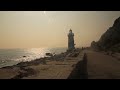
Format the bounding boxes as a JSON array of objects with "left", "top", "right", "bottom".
[{"left": 0, "top": 11, "right": 120, "bottom": 48}]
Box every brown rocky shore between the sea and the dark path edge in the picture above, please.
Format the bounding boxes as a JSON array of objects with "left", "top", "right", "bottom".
[{"left": 0, "top": 49, "right": 84, "bottom": 79}]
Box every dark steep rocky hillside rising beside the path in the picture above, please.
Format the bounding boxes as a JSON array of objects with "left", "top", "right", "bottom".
[{"left": 91, "top": 17, "right": 120, "bottom": 51}]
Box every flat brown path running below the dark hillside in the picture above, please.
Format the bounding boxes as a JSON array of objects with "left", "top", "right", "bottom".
[{"left": 85, "top": 51, "right": 120, "bottom": 79}]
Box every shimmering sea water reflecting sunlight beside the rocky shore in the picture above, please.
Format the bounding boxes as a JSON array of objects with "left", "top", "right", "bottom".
[{"left": 0, "top": 48, "right": 67, "bottom": 68}]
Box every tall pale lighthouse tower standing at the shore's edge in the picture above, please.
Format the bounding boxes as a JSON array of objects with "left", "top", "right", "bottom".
[{"left": 68, "top": 29, "right": 75, "bottom": 51}]
